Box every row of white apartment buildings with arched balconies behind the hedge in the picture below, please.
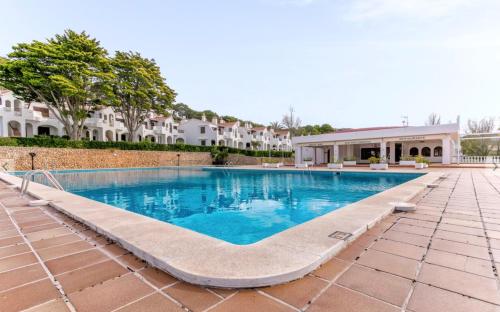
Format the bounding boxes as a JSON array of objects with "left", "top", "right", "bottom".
[{"left": 0, "top": 90, "right": 292, "bottom": 151}]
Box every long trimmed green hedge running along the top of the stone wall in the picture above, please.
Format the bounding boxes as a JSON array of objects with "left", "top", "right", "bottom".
[{"left": 0, "top": 136, "right": 292, "bottom": 157}]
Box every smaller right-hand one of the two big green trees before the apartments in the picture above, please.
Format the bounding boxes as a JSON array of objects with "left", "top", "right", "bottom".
[{"left": 111, "top": 51, "right": 176, "bottom": 141}]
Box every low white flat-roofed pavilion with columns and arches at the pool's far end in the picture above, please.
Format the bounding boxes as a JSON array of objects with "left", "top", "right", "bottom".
[{"left": 292, "top": 122, "right": 460, "bottom": 164}]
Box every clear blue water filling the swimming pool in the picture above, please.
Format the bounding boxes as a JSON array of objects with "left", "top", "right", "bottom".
[{"left": 17, "top": 168, "right": 420, "bottom": 245}]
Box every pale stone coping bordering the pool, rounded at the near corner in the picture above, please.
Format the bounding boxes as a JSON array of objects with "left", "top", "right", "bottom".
[{"left": 0, "top": 168, "right": 442, "bottom": 288}]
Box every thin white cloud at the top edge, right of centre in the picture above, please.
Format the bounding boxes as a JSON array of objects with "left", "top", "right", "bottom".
[{"left": 347, "top": 0, "right": 477, "bottom": 20}]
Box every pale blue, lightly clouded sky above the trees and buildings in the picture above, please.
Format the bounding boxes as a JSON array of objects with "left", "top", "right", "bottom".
[{"left": 0, "top": 0, "right": 500, "bottom": 128}]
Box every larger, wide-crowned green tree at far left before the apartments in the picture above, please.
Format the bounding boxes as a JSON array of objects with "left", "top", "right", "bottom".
[{"left": 0, "top": 30, "right": 113, "bottom": 140}]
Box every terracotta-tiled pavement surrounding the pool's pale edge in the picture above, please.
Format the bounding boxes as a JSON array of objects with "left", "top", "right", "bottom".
[{"left": 0, "top": 169, "right": 500, "bottom": 312}]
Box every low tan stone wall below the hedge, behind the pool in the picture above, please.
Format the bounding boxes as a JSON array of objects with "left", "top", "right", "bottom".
[{"left": 0, "top": 146, "right": 293, "bottom": 170}]
